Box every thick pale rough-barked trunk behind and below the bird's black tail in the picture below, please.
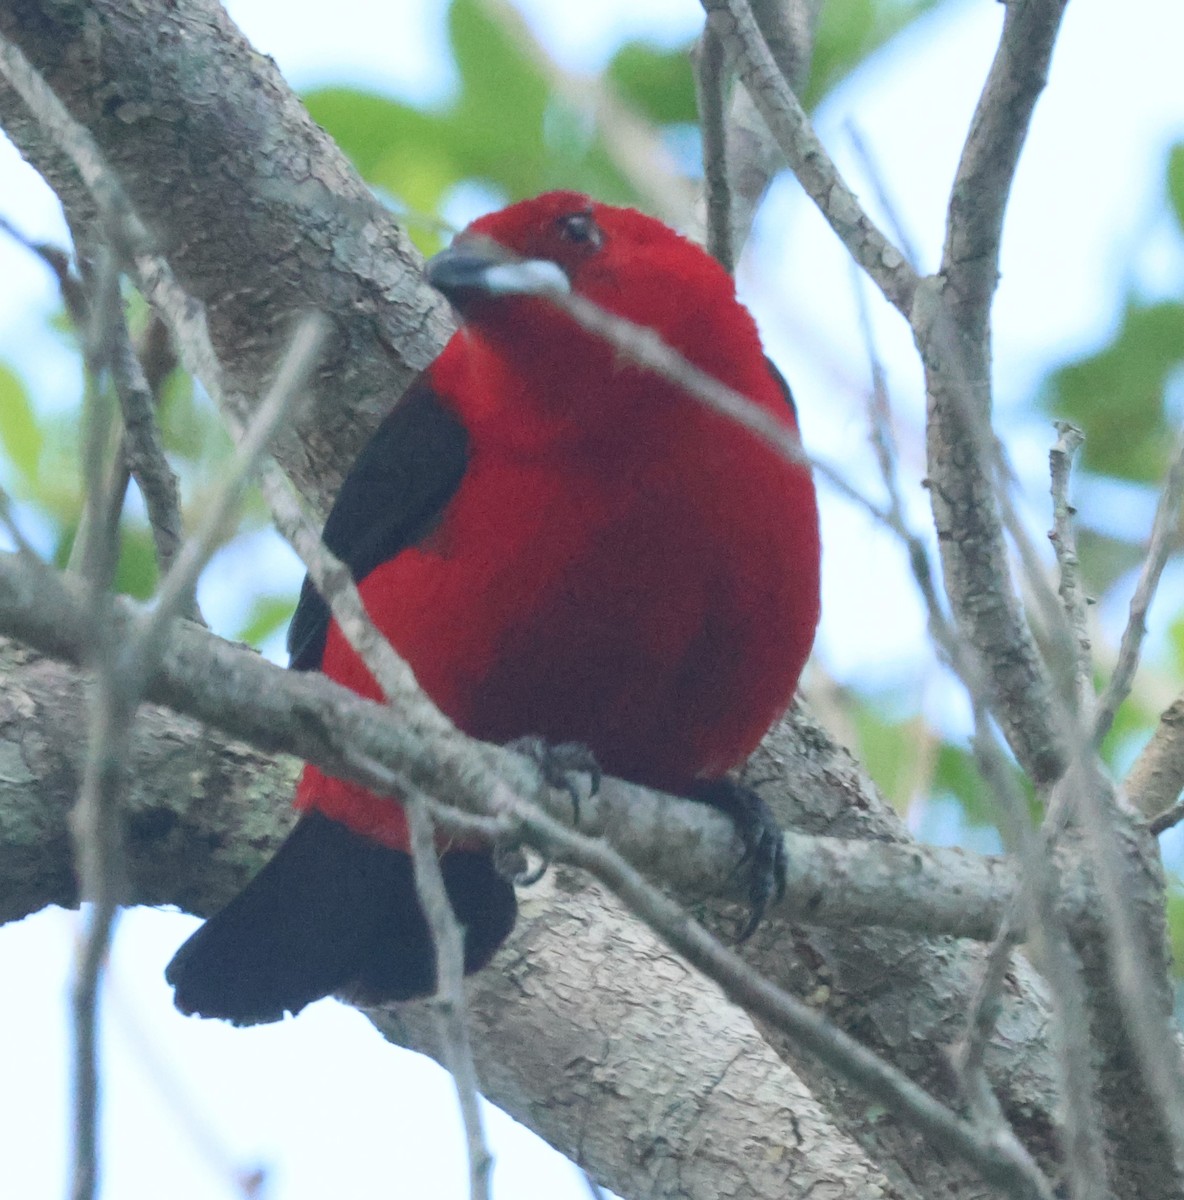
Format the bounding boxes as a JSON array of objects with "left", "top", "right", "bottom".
[{"left": 0, "top": 640, "right": 918, "bottom": 1200}]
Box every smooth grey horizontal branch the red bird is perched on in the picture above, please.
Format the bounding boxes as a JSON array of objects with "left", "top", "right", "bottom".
[{"left": 0, "top": 553, "right": 1014, "bottom": 938}]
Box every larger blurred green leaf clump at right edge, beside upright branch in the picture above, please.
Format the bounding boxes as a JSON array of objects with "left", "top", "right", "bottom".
[{"left": 1045, "top": 300, "right": 1184, "bottom": 482}]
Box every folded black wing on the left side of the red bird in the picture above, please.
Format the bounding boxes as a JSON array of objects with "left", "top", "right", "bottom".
[{"left": 288, "top": 374, "right": 469, "bottom": 671}]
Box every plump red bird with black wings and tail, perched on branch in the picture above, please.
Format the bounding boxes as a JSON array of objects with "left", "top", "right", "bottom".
[{"left": 167, "top": 192, "right": 819, "bottom": 1024}]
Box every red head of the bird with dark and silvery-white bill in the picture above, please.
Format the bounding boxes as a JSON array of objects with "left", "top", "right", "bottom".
[{"left": 427, "top": 192, "right": 786, "bottom": 444}]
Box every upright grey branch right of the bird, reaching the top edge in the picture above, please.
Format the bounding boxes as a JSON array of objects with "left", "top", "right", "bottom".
[{"left": 912, "top": 0, "right": 1064, "bottom": 784}]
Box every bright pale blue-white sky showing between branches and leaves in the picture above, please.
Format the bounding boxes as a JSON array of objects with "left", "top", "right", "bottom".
[{"left": 0, "top": 0, "right": 1184, "bottom": 1200}]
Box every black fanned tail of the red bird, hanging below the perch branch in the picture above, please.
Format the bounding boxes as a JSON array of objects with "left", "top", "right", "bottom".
[{"left": 164, "top": 812, "right": 517, "bottom": 1025}]
